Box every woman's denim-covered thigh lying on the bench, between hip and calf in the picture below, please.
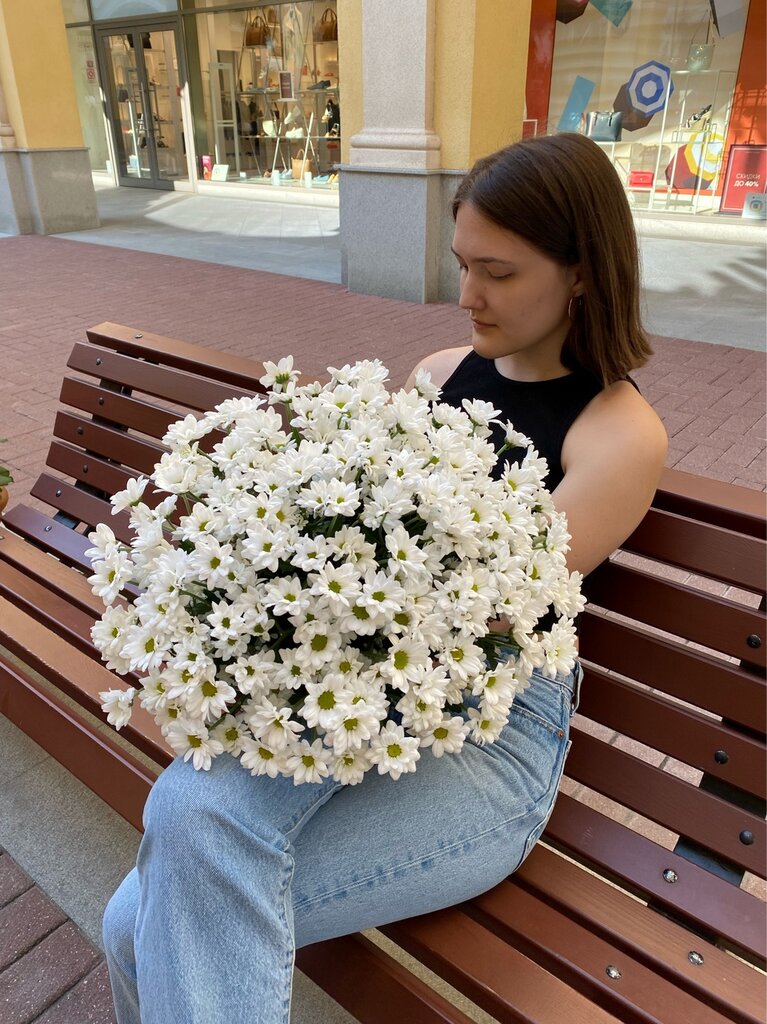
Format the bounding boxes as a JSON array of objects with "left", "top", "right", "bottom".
[{"left": 292, "top": 679, "right": 570, "bottom": 946}]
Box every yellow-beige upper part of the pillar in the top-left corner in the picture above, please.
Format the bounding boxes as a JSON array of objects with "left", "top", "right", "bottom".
[{"left": 0, "top": 0, "right": 83, "bottom": 148}]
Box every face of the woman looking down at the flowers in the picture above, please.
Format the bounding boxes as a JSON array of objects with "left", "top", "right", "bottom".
[{"left": 453, "top": 203, "right": 583, "bottom": 380}]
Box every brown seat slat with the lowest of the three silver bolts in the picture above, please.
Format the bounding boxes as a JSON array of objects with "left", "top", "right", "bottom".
[{"left": 467, "top": 882, "right": 759, "bottom": 1024}]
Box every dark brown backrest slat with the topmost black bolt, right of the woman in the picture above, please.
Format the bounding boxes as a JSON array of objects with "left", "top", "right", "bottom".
[{"left": 589, "top": 562, "right": 767, "bottom": 668}]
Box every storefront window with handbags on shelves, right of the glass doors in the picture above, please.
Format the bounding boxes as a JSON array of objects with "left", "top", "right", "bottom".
[{"left": 184, "top": 0, "right": 341, "bottom": 188}]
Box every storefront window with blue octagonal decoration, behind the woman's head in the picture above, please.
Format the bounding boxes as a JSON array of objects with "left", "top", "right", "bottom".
[{"left": 548, "top": 0, "right": 747, "bottom": 213}]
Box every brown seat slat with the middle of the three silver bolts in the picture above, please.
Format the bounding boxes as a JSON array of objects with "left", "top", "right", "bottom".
[{"left": 509, "top": 844, "right": 767, "bottom": 1024}]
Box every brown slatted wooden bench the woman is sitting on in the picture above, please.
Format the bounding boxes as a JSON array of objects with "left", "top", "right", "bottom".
[{"left": 0, "top": 324, "right": 766, "bottom": 1024}]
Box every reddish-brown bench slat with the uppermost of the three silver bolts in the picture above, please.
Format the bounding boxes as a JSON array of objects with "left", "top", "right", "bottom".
[{"left": 545, "top": 793, "right": 767, "bottom": 965}]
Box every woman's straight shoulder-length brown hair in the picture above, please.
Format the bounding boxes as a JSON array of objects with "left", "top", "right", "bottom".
[{"left": 453, "top": 132, "right": 652, "bottom": 385}]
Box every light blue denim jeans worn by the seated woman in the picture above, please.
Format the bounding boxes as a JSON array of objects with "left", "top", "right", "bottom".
[{"left": 103, "top": 667, "right": 581, "bottom": 1024}]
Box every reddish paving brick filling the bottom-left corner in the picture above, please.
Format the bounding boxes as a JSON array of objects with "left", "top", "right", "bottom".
[{"left": 0, "top": 922, "right": 101, "bottom": 1024}]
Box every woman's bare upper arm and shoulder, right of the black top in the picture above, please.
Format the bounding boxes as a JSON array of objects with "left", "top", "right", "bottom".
[{"left": 553, "top": 381, "right": 668, "bottom": 574}]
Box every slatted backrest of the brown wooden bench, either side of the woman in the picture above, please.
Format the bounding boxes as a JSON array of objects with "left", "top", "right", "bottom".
[{"left": 6, "top": 324, "right": 767, "bottom": 962}]
